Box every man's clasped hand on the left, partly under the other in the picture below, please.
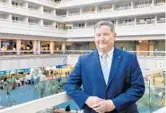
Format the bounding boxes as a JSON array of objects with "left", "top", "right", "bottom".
[{"left": 85, "top": 96, "right": 104, "bottom": 108}]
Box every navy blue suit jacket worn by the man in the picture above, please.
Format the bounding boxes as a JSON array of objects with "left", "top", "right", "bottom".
[{"left": 64, "top": 47, "right": 145, "bottom": 113}]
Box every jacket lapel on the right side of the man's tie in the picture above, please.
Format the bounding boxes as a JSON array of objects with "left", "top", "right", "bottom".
[{"left": 107, "top": 47, "right": 122, "bottom": 88}]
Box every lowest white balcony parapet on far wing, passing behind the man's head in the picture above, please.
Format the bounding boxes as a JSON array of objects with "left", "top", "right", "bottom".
[{"left": 68, "top": 23, "right": 165, "bottom": 41}]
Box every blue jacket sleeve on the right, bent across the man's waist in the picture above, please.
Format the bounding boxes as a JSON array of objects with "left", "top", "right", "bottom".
[{"left": 112, "top": 55, "right": 145, "bottom": 110}]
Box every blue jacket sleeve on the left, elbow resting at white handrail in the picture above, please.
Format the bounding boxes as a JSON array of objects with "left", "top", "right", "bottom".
[{"left": 64, "top": 57, "right": 88, "bottom": 109}]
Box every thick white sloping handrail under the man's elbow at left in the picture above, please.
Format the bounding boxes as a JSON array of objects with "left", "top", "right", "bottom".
[{"left": 0, "top": 92, "right": 70, "bottom": 113}]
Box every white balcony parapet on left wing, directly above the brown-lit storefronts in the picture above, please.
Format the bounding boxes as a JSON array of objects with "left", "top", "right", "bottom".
[{"left": 0, "top": 21, "right": 67, "bottom": 40}]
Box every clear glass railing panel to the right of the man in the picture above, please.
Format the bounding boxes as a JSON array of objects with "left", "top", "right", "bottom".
[{"left": 137, "top": 68, "right": 166, "bottom": 113}]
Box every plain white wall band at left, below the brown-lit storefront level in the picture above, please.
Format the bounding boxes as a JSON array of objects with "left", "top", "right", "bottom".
[{"left": 0, "top": 55, "right": 67, "bottom": 70}]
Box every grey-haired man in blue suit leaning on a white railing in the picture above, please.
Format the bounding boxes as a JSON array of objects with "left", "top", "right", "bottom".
[{"left": 64, "top": 21, "right": 145, "bottom": 113}]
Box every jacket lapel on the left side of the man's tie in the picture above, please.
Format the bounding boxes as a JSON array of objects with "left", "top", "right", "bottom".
[{"left": 94, "top": 50, "right": 106, "bottom": 87}]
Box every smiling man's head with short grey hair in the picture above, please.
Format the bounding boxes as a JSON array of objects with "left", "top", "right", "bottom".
[{"left": 94, "top": 21, "right": 116, "bottom": 53}]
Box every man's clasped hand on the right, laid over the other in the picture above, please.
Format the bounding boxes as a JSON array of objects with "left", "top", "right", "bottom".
[{"left": 92, "top": 100, "right": 115, "bottom": 113}]
